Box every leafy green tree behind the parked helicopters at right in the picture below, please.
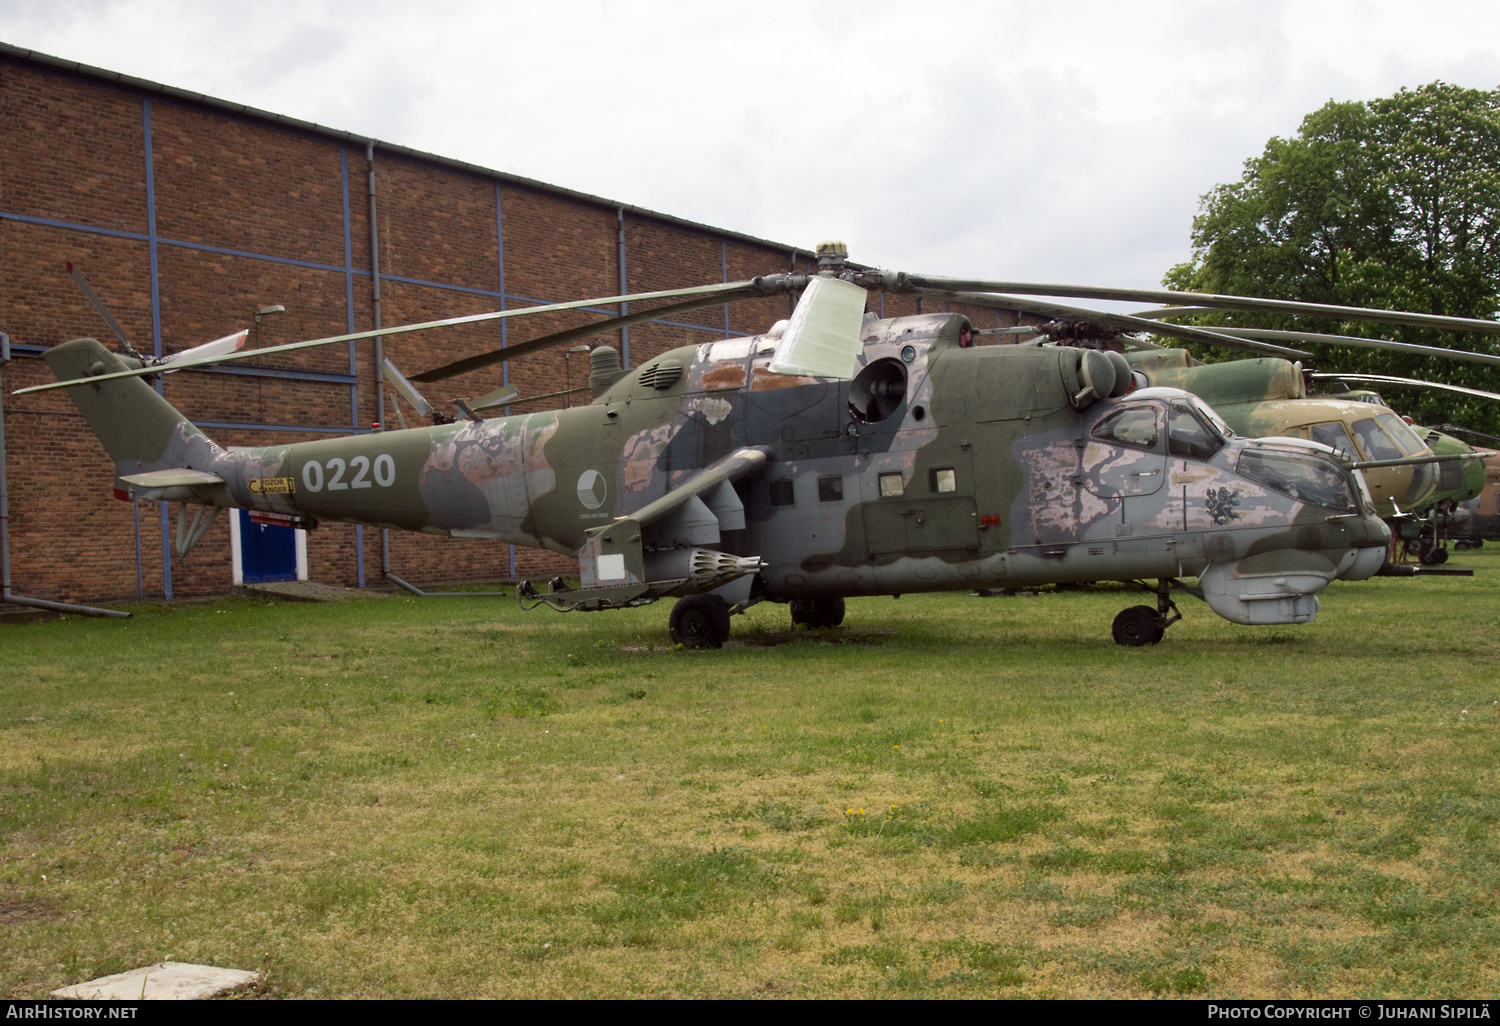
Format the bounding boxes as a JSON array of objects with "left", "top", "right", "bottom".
[{"left": 1164, "top": 83, "right": 1500, "bottom": 429}]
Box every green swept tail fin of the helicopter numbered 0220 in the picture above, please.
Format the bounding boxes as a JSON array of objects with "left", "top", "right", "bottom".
[{"left": 45, "top": 339, "right": 222, "bottom": 477}]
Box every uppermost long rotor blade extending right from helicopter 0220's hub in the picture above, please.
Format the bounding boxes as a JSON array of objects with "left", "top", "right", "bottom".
[{"left": 879, "top": 272, "right": 1500, "bottom": 335}]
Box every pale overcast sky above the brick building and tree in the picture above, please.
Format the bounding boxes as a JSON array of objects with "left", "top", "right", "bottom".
[{"left": 0, "top": 0, "right": 1500, "bottom": 287}]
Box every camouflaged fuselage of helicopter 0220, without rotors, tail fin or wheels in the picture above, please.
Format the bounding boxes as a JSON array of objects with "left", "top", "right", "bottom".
[{"left": 215, "top": 314, "right": 1388, "bottom": 599}]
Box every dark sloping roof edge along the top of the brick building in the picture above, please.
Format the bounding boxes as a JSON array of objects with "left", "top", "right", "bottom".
[{"left": 0, "top": 42, "right": 816, "bottom": 260}]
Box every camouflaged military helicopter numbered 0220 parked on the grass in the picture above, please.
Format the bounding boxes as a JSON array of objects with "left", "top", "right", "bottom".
[{"left": 21, "top": 243, "right": 1500, "bottom": 648}]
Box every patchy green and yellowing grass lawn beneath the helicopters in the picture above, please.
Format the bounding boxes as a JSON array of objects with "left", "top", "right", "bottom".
[{"left": 0, "top": 549, "right": 1500, "bottom": 998}]
